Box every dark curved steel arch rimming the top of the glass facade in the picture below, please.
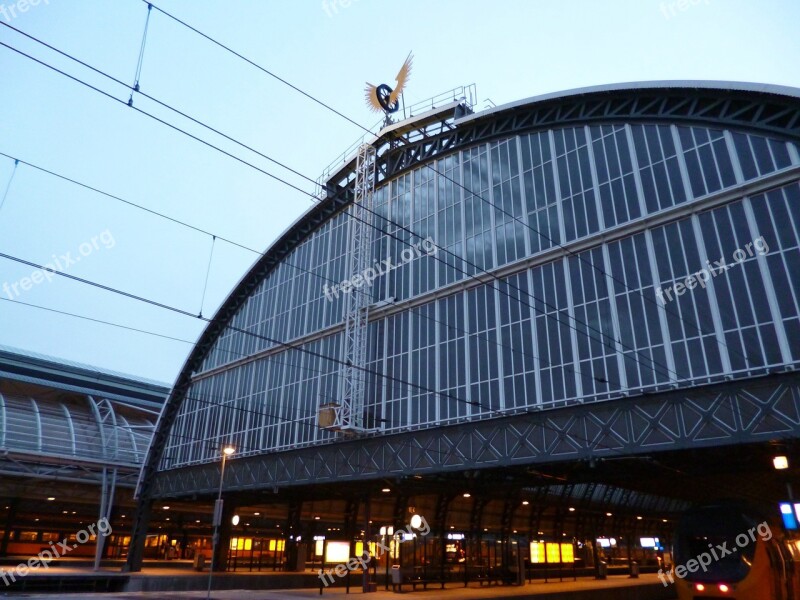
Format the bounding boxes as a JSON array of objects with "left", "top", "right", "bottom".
[{"left": 123, "top": 81, "right": 800, "bottom": 566}]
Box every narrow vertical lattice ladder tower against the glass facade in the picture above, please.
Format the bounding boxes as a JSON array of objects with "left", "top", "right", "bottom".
[{"left": 331, "top": 144, "right": 377, "bottom": 433}]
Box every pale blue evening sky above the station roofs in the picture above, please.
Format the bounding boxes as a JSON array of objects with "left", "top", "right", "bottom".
[{"left": 0, "top": 0, "right": 800, "bottom": 384}]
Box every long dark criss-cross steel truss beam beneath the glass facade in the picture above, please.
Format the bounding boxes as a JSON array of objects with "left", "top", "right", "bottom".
[{"left": 153, "top": 372, "right": 800, "bottom": 498}]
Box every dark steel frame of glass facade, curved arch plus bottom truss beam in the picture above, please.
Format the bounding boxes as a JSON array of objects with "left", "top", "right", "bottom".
[{"left": 129, "top": 82, "right": 800, "bottom": 564}]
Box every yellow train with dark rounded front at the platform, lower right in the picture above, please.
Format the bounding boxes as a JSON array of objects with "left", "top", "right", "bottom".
[{"left": 672, "top": 502, "right": 800, "bottom": 600}]
